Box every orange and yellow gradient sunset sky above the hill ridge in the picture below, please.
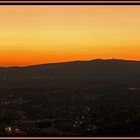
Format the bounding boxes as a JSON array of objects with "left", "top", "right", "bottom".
[{"left": 0, "top": 5, "right": 140, "bottom": 66}]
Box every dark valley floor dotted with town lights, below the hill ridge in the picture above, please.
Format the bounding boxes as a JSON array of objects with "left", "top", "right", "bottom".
[{"left": 0, "top": 79, "right": 140, "bottom": 137}]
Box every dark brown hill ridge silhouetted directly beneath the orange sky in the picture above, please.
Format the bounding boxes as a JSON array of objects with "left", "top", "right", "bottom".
[{"left": 0, "top": 59, "right": 140, "bottom": 81}]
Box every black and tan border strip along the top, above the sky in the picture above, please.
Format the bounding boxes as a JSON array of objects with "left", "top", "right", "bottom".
[{"left": 0, "top": 0, "right": 140, "bottom": 5}]
